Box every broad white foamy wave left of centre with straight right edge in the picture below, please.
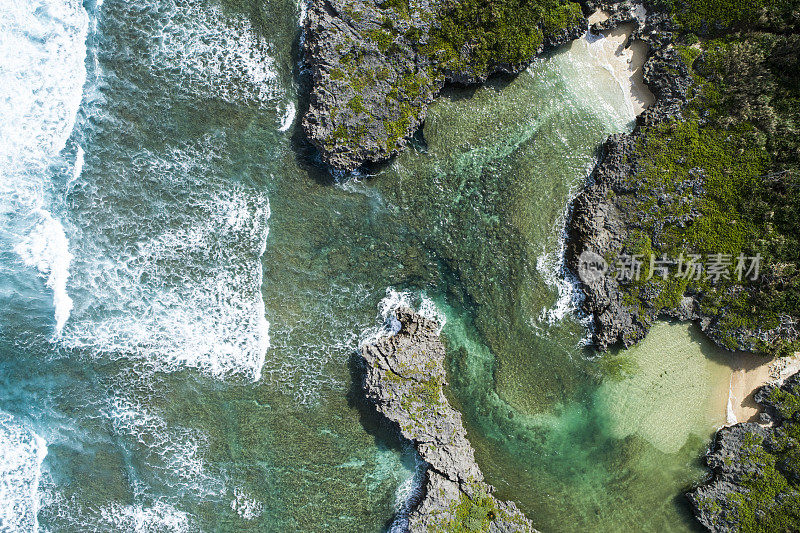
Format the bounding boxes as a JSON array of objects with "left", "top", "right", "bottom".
[{"left": 61, "top": 179, "right": 270, "bottom": 381}]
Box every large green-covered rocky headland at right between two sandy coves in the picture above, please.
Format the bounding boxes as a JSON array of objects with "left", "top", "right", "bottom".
[{"left": 568, "top": 2, "right": 800, "bottom": 353}]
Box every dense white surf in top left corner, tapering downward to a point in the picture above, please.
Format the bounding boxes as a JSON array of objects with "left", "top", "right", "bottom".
[{"left": 0, "top": 0, "right": 88, "bottom": 333}]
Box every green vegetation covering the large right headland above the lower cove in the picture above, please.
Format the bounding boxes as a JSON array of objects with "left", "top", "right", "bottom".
[{"left": 611, "top": 8, "right": 800, "bottom": 353}]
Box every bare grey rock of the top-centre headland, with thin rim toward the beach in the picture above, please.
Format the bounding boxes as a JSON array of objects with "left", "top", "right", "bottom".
[{"left": 303, "top": 0, "right": 586, "bottom": 170}]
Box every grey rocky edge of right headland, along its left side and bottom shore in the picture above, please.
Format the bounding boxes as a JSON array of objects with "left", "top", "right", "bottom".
[{"left": 566, "top": 2, "right": 800, "bottom": 352}]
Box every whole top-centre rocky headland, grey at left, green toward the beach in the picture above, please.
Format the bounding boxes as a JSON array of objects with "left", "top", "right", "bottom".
[{"left": 303, "top": 0, "right": 586, "bottom": 170}]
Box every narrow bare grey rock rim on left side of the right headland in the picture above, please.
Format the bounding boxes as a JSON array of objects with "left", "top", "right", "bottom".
[{"left": 566, "top": 2, "right": 696, "bottom": 350}]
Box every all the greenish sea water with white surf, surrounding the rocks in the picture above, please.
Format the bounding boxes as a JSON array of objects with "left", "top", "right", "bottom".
[{"left": 0, "top": 0, "right": 736, "bottom": 531}]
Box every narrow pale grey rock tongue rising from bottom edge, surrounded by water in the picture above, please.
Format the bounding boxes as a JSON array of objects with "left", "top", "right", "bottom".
[{"left": 361, "top": 308, "right": 533, "bottom": 533}]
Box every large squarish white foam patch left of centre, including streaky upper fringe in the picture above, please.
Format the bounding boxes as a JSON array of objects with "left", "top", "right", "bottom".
[{"left": 62, "top": 141, "right": 270, "bottom": 381}]
